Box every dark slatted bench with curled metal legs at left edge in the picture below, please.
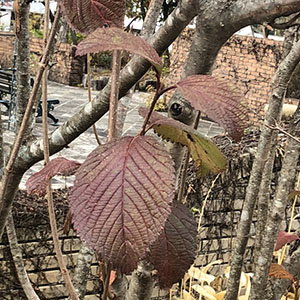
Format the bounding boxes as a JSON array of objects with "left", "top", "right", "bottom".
[{"left": 0, "top": 69, "right": 59, "bottom": 127}]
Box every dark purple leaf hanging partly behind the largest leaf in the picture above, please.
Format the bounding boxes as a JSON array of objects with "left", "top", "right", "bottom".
[{"left": 150, "top": 202, "right": 197, "bottom": 288}]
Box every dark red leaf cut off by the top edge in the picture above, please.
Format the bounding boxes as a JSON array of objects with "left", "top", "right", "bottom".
[{"left": 59, "top": 0, "right": 126, "bottom": 34}]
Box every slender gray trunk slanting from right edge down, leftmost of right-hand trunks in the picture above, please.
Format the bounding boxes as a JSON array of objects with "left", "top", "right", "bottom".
[{"left": 225, "top": 37, "right": 300, "bottom": 300}]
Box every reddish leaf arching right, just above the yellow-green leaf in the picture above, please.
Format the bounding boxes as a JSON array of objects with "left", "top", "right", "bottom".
[{"left": 176, "top": 75, "right": 248, "bottom": 140}]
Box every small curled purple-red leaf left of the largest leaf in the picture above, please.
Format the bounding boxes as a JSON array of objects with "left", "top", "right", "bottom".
[{"left": 26, "top": 157, "right": 80, "bottom": 196}]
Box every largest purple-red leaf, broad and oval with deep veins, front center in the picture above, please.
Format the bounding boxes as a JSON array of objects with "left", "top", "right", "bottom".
[{"left": 69, "top": 136, "right": 175, "bottom": 273}]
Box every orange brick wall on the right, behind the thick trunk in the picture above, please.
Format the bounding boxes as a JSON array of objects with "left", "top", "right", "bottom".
[{"left": 168, "top": 30, "right": 282, "bottom": 122}]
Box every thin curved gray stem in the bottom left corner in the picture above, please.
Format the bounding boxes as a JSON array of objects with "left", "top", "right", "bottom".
[{"left": 6, "top": 212, "right": 40, "bottom": 300}]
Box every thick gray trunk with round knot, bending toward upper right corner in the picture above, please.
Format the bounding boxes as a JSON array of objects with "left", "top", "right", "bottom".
[{"left": 168, "top": 0, "right": 300, "bottom": 186}]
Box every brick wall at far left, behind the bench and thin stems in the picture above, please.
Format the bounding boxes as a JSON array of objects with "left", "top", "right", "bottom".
[{"left": 0, "top": 33, "right": 83, "bottom": 86}]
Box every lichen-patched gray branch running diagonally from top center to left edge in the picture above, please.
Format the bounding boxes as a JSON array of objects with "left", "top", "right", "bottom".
[{"left": 0, "top": 0, "right": 198, "bottom": 238}]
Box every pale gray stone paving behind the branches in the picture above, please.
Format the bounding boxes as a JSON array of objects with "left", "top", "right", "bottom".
[{"left": 16, "top": 82, "right": 223, "bottom": 188}]
